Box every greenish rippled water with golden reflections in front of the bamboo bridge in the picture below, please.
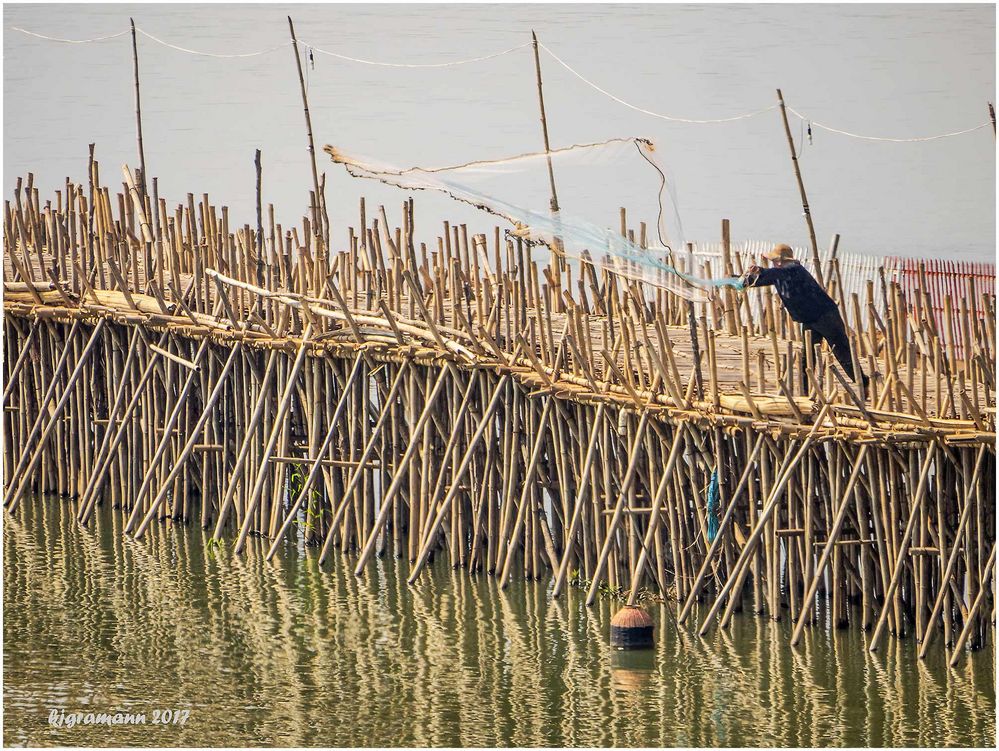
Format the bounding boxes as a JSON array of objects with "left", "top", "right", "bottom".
[{"left": 3, "top": 501, "right": 995, "bottom": 746}]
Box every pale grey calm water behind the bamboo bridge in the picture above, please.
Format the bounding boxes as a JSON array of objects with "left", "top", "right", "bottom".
[{"left": 3, "top": 4, "right": 996, "bottom": 260}]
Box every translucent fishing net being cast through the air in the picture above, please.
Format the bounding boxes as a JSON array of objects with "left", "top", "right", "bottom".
[{"left": 325, "top": 138, "right": 741, "bottom": 301}]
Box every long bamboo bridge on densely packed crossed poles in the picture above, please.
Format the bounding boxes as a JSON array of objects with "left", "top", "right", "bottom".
[{"left": 4, "top": 162, "right": 996, "bottom": 662}]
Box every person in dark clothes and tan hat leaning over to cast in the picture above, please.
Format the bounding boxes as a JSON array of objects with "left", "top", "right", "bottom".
[{"left": 742, "top": 243, "right": 870, "bottom": 391}]
